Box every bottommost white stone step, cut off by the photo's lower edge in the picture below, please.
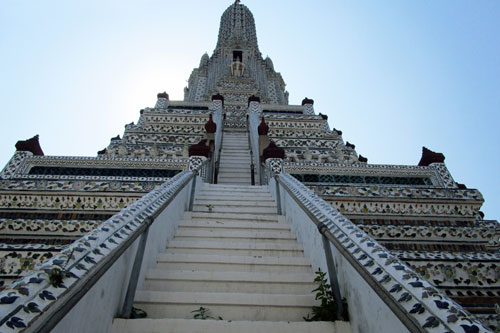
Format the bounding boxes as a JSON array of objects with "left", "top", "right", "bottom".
[{"left": 111, "top": 318, "right": 351, "bottom": 333}]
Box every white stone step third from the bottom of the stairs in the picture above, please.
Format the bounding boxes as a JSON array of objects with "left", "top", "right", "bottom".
[{"left": 144, "top": 269, "right": 317, "bottom": 295}]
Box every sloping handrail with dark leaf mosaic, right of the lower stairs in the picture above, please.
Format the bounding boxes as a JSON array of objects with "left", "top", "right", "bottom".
[{"left": 269, "top": 172, "right": 491, "bottom": 332}]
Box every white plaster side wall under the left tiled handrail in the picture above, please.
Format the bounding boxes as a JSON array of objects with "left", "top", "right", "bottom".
[{"left": 52, "top": 177, "right": 196, "bottom": 333}]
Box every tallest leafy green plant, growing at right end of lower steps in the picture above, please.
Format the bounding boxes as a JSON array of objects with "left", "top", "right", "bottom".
[{"left": 303, "top": 268, "right": 349, "bottom": 321}]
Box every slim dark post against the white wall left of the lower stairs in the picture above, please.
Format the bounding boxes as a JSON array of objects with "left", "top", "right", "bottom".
[{"left": 120, "top": 216, "right": 154, "bottom": 319}]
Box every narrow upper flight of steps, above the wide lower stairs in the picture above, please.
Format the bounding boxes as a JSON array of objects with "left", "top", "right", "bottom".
[{"left": 217, "top": 128, "right": 251, "bottom": 185}]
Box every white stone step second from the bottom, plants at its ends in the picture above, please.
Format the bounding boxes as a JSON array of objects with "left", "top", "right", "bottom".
[{"left": 134, "top": 290, "right": 318, "bottom": 321}]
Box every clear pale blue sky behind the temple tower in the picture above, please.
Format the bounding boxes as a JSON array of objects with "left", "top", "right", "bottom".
[{"left": 0, "top": 0, "right": 500, "bottom": 218}]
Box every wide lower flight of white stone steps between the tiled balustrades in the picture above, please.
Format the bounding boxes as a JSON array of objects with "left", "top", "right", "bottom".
[{"left": 113, "top": 184, "right": 350, "bottom": 333}]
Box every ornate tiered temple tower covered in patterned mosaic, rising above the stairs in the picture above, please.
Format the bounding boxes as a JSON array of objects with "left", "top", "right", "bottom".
[{"left": 0, "top": 1, "right": 500, "bottom": 327}]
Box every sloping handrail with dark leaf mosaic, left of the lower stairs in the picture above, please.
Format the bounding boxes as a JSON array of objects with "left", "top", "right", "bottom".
[{"left": 0, "top": 170, "right": 198, "bottom": 332}]
